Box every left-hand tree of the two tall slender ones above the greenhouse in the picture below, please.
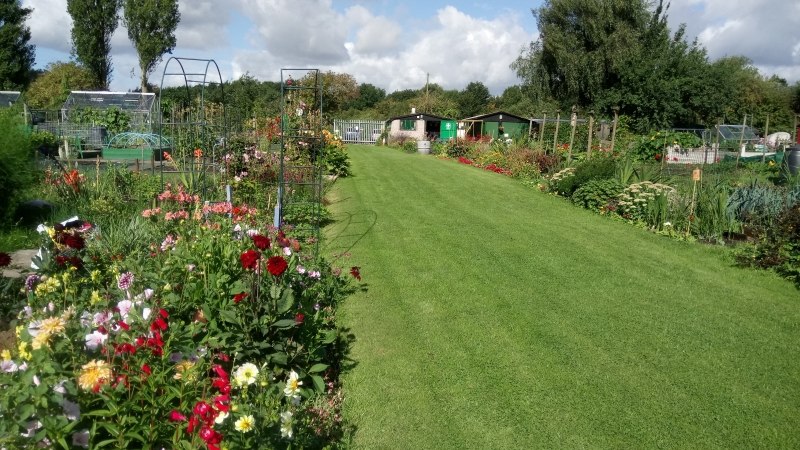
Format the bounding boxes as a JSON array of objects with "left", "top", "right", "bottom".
[{"left": 67, "top": 0, "right": 122, "bottom": 90}]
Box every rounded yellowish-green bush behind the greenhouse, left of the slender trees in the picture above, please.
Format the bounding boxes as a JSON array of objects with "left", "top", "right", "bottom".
[{"left": 25, "top": 61, "right": 98, "bottom": 109}]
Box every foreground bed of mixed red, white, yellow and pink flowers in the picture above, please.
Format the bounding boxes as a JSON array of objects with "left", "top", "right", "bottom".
[{"left": 0, "top": 190, "right": 361, "bottom": 450}]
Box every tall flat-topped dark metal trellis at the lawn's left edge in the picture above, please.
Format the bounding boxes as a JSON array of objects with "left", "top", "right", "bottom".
[{"left": 274, "top": 69, "right": 324, "bottom": 255}]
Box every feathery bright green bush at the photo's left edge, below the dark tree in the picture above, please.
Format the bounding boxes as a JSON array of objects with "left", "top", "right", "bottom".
[{"left": 0, "top": 105, "right": 36, "bottom": 225}]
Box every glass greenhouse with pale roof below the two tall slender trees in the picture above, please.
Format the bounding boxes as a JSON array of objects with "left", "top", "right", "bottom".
[{"left": 61, "top": 91, "right": 159, "bottom": 133}]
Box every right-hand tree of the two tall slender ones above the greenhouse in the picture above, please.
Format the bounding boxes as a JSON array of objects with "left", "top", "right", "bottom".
[{"left": 123, "top": 0, "right": 181, "bottom": 92}]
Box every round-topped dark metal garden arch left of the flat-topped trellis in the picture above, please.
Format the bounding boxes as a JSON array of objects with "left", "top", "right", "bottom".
[{"left": 157, "top": 57, "right": 228, "bottom": 201}]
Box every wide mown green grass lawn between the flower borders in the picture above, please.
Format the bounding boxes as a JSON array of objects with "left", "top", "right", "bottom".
[{"left": 324, "top": 146, "right": 800, "bottom": 449}]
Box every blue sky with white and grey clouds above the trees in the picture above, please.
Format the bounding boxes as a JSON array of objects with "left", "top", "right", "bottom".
[{"left": 22, "top": 0, "right": 800, "bottom": 95}]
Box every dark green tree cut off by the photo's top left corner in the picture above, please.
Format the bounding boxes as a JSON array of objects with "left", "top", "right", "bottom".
[{"left": 0, "top": 0, "right": 36, "bottom": 90}]
